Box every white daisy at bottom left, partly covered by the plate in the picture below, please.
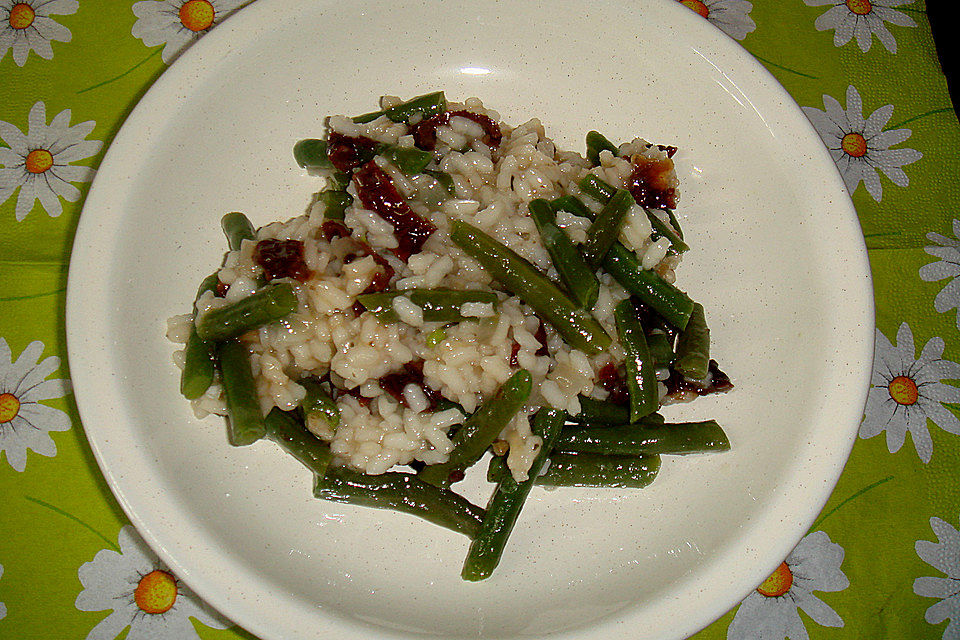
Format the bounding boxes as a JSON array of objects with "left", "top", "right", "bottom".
[{"left": 76, "top": 525, "right": 232, "bottom": 640}]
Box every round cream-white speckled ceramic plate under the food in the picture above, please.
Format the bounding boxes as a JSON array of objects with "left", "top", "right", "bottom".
[{"left": 67, "top": 0, "right": 873, "bottom": 640}]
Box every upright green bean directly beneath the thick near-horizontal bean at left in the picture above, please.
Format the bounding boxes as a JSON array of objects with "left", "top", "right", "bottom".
[{"left": 217, "top": 340, "right": 266, "bottom": 447}]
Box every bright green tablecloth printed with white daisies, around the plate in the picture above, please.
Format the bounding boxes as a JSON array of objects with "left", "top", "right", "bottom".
[{"left": 0, "top": 0, "right": 960, "bottom": 640}]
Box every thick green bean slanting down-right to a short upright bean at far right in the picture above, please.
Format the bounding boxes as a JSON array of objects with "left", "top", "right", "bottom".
[{"left": 603, "top": 243, "right": 693, "bottom": 331}]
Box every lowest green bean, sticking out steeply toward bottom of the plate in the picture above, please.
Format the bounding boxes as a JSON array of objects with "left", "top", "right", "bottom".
[{"left": 460, "top": 409, "right": 566, "bottom": 582}]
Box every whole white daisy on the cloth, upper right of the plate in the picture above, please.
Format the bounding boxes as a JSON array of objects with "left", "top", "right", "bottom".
[{"left": 803, "top": 85, "right": 923, "bottom": 202}]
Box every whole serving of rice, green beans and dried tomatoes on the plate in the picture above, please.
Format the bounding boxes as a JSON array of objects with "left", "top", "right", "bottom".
[{"left": 168, "top": 92, "right": 732, "bottom": 580}]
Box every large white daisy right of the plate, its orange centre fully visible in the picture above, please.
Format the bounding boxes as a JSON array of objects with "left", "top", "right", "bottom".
[{"left": 860, "top": 322, "right": 960, "bottom": 462}]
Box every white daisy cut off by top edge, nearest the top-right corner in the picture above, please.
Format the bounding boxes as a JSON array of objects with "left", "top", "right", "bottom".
[{"left": 804, "top": 0, "right": 917, "bottom": 53}]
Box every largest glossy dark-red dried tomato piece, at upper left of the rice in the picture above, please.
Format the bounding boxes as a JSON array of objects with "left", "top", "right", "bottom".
[{"left": 353, "top": 162, "right": 437, "bottom": 262}]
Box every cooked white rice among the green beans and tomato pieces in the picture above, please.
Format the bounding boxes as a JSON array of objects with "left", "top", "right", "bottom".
[{"left": 167, "top": 97, "right": 677, "bottom": 479}]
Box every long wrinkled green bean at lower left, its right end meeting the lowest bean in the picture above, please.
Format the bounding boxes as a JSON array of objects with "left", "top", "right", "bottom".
[{"left": 313, "top": 466, "right": 486, "bottom": 538}]
